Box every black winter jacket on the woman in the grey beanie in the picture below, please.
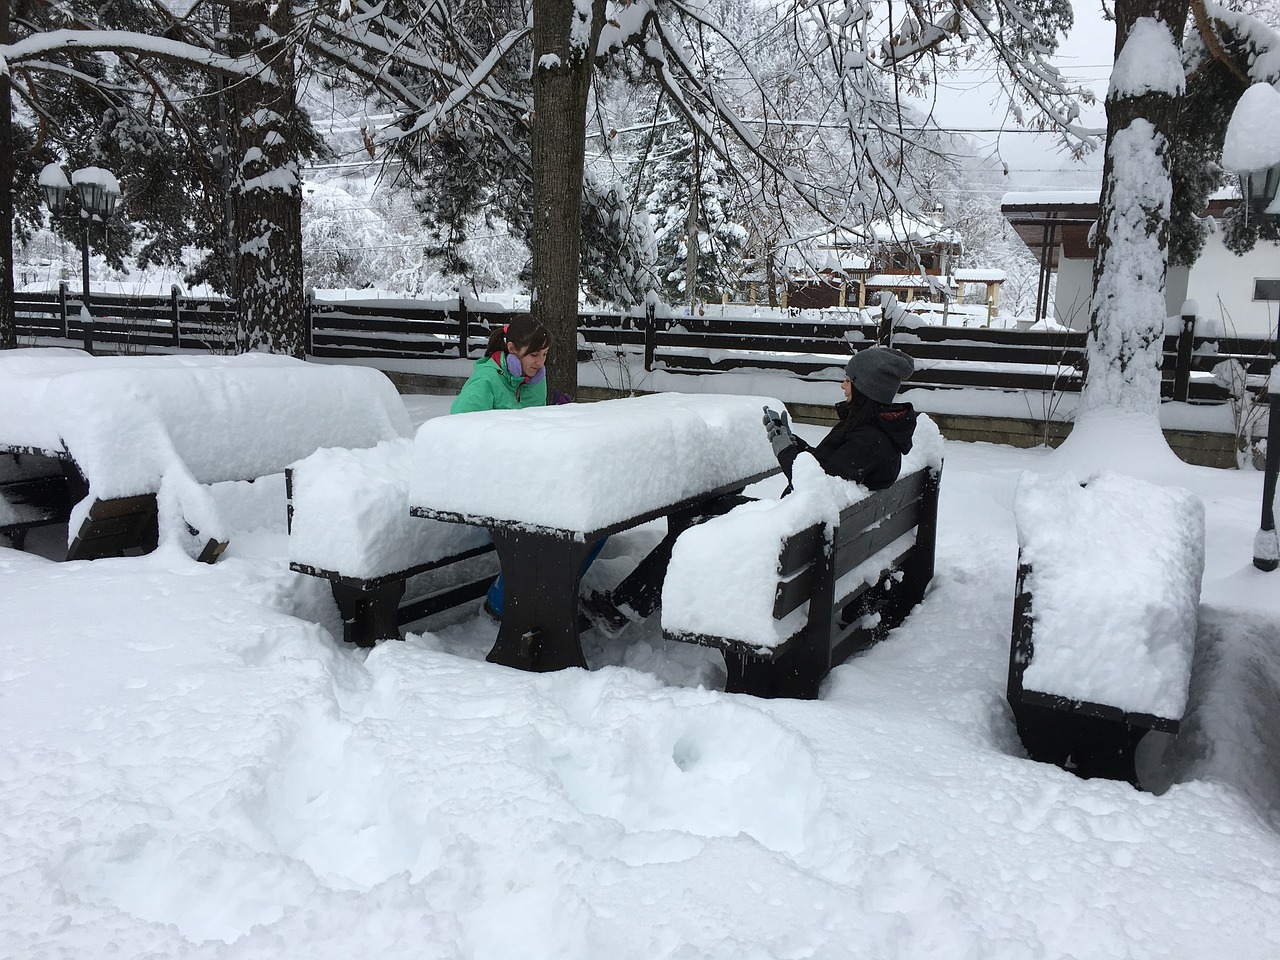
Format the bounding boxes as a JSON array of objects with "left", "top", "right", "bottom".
[{"left": 778, "top": 402, "right": 919, "bottom": 490}]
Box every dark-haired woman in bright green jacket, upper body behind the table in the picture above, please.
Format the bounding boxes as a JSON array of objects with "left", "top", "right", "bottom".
[{"left": 449, "top": 316, "right": 552, "bottom": 413}]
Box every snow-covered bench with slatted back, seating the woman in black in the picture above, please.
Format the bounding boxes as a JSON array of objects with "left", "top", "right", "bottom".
[{"left": 662, "top": 417, "right": 942, "bottom": 699}]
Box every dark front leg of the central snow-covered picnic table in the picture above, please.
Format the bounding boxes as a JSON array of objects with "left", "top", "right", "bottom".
[{"left": 485, "top": 527, "right": 594, "bottom": 672}]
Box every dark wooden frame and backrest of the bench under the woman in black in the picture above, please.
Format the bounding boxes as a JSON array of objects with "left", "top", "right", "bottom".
[{"left": 663, "top": 467, "right": 941, "bottom": 699}]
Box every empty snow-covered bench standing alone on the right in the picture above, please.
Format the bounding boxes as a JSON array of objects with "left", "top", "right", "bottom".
[{"left": 1007, "top": 474, "right": 1204, "bottom": 786}]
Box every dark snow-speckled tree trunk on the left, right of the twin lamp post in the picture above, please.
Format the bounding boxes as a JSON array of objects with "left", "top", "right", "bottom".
[{"left": 228, "top": 0, "right": 307, "bottom": 357}]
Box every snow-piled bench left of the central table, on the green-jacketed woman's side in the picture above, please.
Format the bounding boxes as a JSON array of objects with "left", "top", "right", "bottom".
[{"left": 285, "top": 438, "right": 495, "bottom": 646}]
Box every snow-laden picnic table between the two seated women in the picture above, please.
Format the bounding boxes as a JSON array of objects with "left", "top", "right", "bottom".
[{"left": 408, "top": 394, "right": 778, "bottom": 671}]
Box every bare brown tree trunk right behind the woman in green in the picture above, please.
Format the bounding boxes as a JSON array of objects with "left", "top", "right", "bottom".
[{"left": 530, "top": 0, "right": 604, "bottom": 397}]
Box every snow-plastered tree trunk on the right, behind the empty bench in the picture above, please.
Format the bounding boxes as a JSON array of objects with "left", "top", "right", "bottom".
[{"left": 1078, "top": 0, "right": 1187, "bottom": 424}]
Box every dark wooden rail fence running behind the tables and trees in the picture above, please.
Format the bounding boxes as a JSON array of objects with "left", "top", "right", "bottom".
[{"left": 14, "top": 284, "right": 1272, "bottom": 403}]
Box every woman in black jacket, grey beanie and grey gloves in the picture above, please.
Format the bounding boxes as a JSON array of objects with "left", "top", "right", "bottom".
[{"left": 764, "top": 347, "right": 918, "bottom": 490}]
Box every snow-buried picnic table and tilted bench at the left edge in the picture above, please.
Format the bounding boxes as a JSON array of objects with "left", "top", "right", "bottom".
[{"left": 0, "top": 348, "right": 410, "bottom": 559}]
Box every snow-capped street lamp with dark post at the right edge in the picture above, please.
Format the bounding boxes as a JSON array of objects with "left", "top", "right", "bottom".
[{"left": 1222, "top": 83, "right": 1280, "bottom": 570}]
